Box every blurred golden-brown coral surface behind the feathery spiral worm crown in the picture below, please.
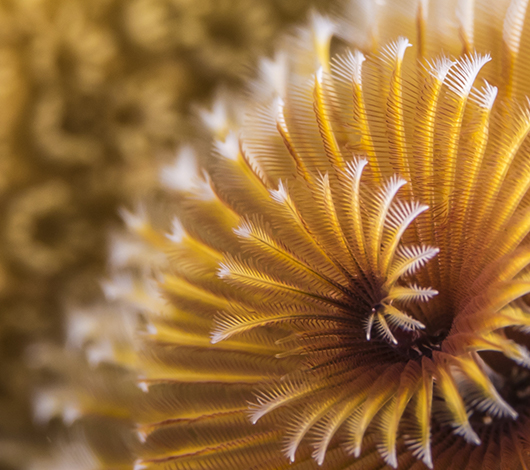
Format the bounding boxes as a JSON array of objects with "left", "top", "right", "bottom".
[{"left": 0, "top": 0, "right": 332, "bottom": 470}]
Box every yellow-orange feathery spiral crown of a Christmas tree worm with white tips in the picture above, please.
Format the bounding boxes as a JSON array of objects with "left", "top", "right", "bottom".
[{"left": 52, "top": 0, "right": 530, "bottom": 470}]
